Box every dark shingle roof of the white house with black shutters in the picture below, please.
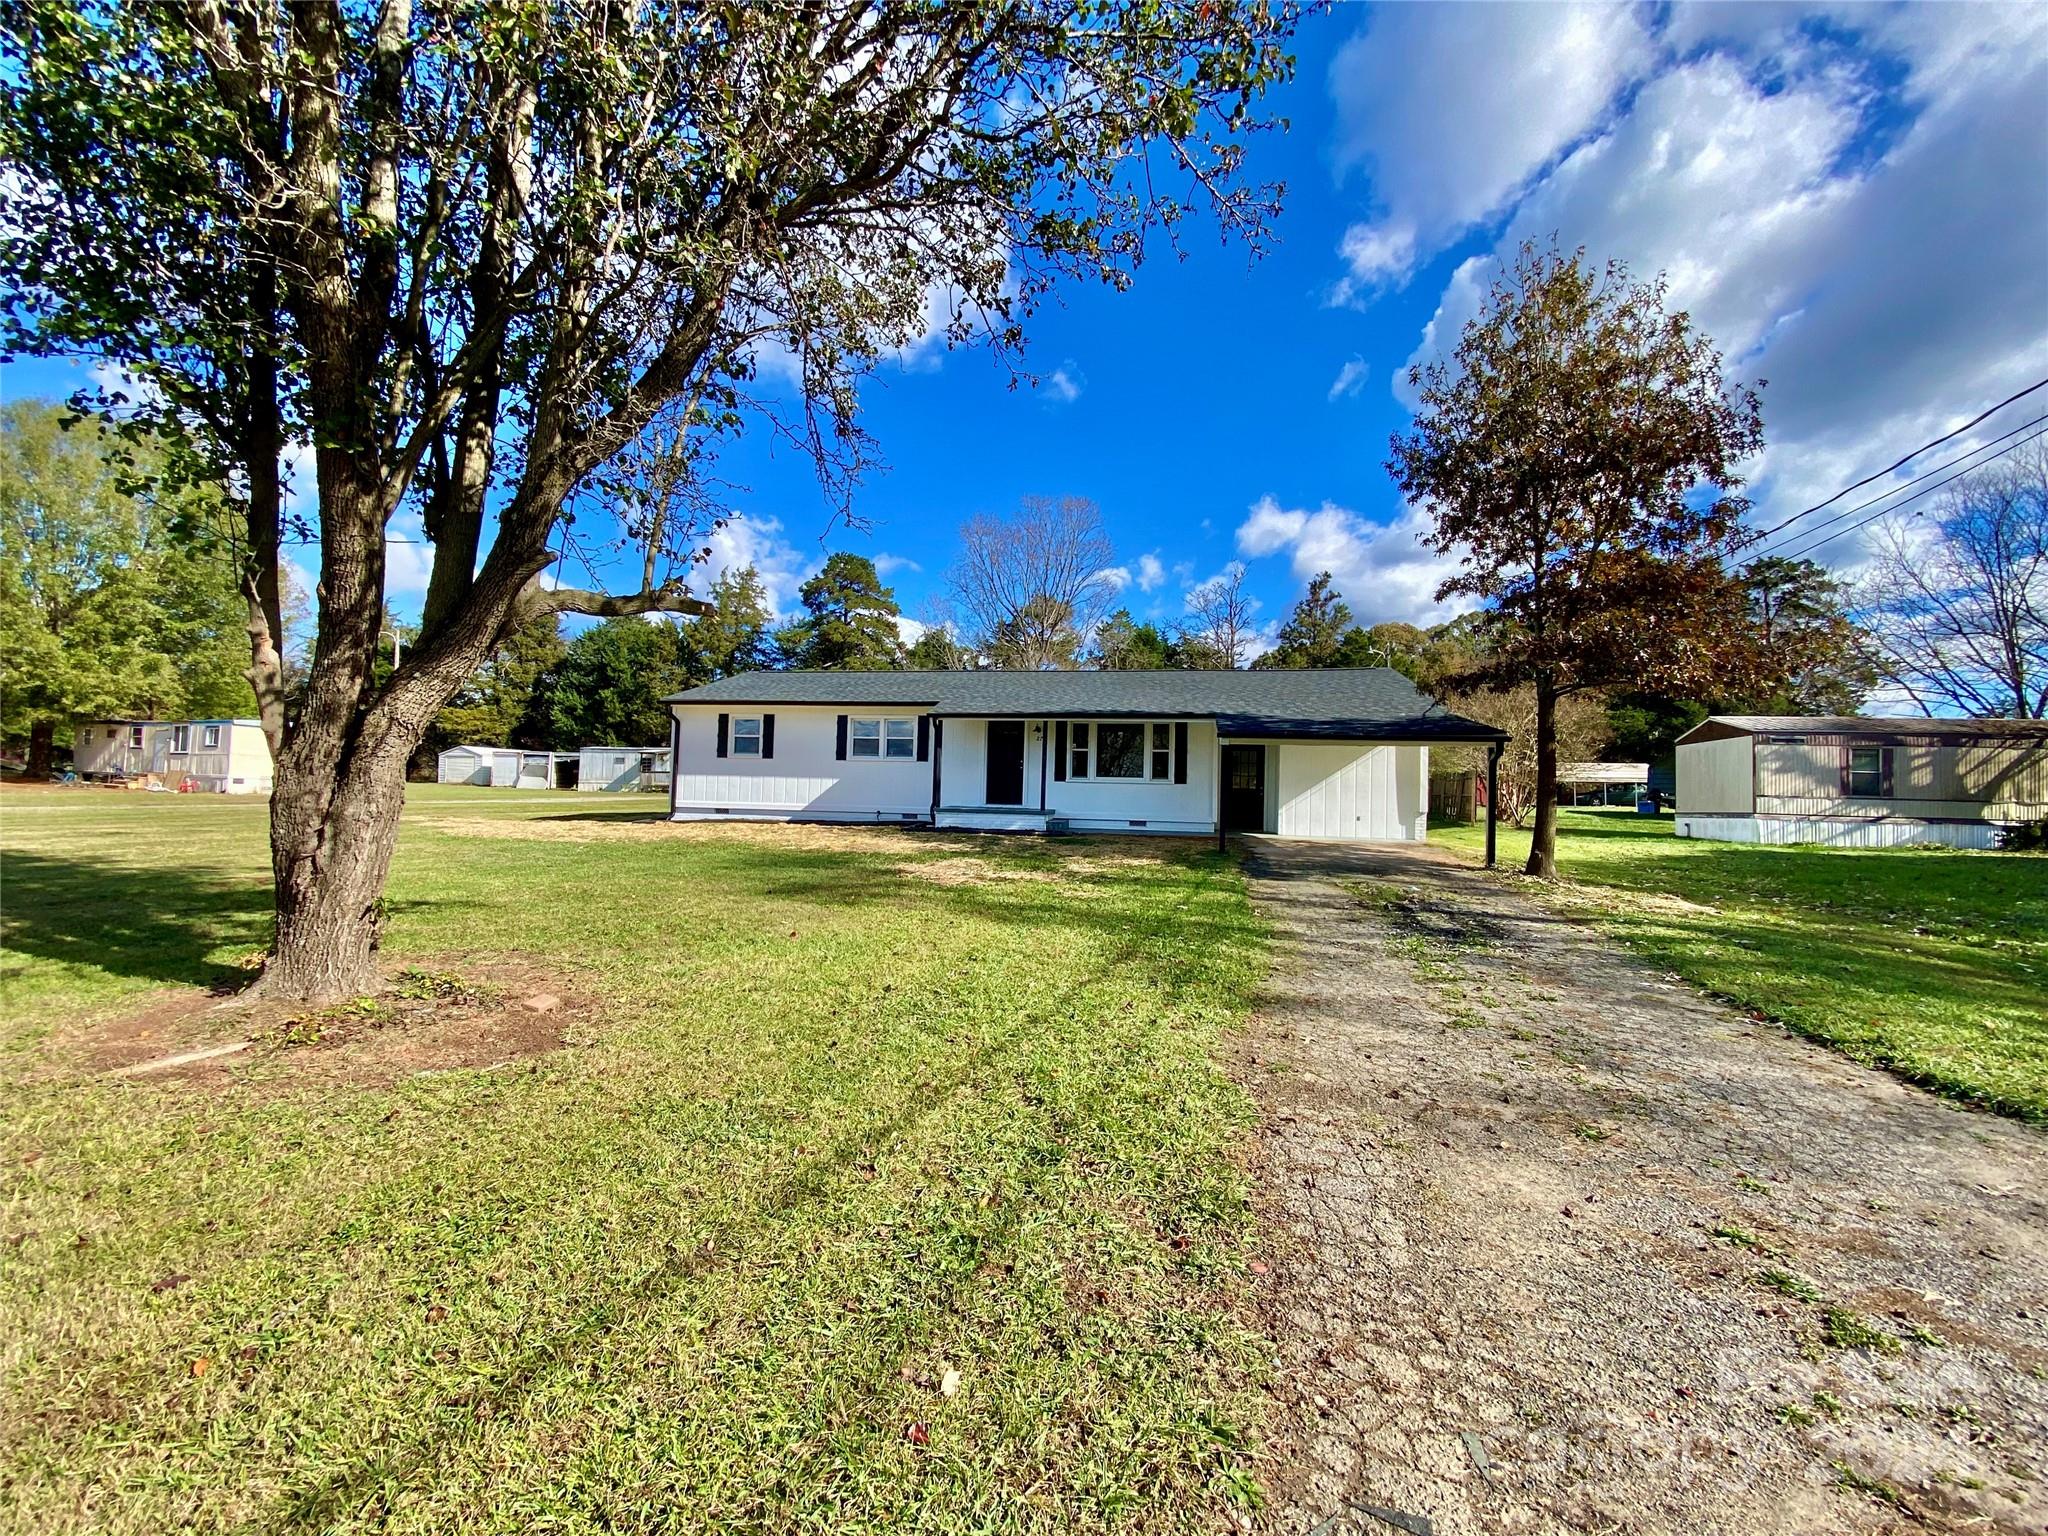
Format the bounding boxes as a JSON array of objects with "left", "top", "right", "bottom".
[{"left": 670, "top": 668, "right": 1507, "bottom": 741}]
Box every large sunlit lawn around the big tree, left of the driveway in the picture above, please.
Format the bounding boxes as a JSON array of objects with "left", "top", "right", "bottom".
[{"left": 0, "top": 786, "right": 1264, "bottom": 1532}]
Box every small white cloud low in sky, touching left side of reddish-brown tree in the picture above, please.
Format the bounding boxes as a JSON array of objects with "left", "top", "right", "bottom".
[{"left": 1237, "top": 496, "right": 1458, "bottom": 625}]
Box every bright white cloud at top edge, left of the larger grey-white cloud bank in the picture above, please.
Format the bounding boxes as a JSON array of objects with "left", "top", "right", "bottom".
[{"left": 1329, "top": 4, "right": 1655, "bottom": 288}]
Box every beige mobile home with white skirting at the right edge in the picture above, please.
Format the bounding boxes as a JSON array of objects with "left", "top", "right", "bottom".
[{"left": 1677, "top": 715, "right": 2048, "bottom": 848}]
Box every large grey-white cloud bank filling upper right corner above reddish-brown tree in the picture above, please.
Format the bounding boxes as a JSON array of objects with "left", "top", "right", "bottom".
[{"left": 1366, "top": 4, "right": 2048, "bottom": 565}]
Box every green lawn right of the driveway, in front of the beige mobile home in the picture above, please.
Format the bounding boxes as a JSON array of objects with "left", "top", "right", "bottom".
[{"left": 1430, "top": 811, "right": 2048, "bottom": 1122}]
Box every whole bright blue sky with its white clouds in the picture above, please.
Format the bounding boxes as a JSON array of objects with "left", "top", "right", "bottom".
[{"left": 6, "top": 4, "right": 2048, "bottom": 651}]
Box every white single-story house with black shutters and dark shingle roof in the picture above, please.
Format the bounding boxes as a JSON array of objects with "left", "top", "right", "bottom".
[{"left": 668, "top": 668, "right": 1507, "bottom": 860}]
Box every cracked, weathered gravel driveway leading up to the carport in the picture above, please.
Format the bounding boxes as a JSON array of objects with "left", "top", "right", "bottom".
[{"left": 1243, "top": 838, "right": 2048, "bottom": 1536}]
